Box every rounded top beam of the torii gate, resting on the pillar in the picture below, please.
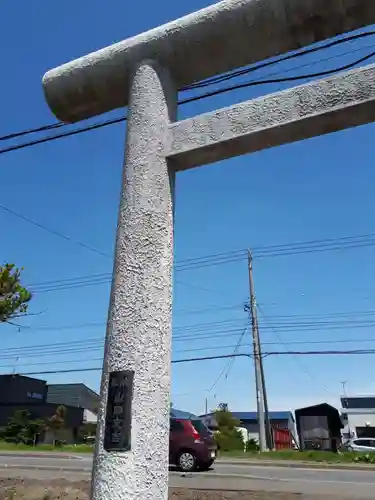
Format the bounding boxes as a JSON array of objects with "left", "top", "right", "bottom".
[{"left": 43, "top": 0, "right": 375, "bottom": 122}]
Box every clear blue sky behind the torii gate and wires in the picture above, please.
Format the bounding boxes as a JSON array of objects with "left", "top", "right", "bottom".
[{"left": 0, "top": 0, "right": 375, "bottom": 412}]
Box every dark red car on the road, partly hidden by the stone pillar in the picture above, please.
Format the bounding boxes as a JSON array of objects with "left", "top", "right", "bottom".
[{"left": 169, "top": 418, "right": 217, "bottom": 472}]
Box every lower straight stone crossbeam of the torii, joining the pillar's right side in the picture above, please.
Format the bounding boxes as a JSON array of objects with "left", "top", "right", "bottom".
[{"left": 168, "top": 63, "right": 375, "bottom": 170}]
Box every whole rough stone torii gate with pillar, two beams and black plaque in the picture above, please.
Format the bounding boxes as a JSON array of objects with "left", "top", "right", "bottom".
[{"left": 43, "top": 0, "right": 375, "bottom": 500}]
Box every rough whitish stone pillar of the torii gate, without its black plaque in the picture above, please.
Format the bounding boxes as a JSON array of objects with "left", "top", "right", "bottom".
[{"left": 92, "top": 62, "right": 177, "bottom": 500}]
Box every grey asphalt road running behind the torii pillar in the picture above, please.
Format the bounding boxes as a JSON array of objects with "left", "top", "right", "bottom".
[{"left": 0, "top": 453, "right": 375, "bottom": 500}]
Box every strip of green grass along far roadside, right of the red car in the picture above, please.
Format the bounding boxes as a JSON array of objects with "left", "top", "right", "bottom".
[{"left": 220, "top": 450, "right": 375, "bottom": 464}]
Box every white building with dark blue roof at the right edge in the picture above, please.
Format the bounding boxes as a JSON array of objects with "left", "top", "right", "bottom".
[{"left": 340, "top": 396, "right": 375, "bottom": 439}]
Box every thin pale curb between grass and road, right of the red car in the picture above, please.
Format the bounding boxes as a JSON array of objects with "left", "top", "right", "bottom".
[{"left": 215, "top": 458, "right": 375, "bottom": 471}]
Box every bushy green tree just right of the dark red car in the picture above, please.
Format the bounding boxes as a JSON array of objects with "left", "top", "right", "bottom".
[{"left": 215, "top": 405, "right": 244, "bottom": 451}]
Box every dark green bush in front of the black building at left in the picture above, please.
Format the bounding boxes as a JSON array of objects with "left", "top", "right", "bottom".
[{"left": 2, "top": 410, "right": 45, "bottom": 444}]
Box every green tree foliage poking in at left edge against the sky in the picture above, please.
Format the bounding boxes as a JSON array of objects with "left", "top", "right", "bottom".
[{"left": 0, "top": 264, "right": 31, "bottom": 323}]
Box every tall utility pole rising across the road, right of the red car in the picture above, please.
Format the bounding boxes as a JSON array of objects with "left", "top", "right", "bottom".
[{"left": 247, "top": 250, "right": 269, "bottom": 452}]
